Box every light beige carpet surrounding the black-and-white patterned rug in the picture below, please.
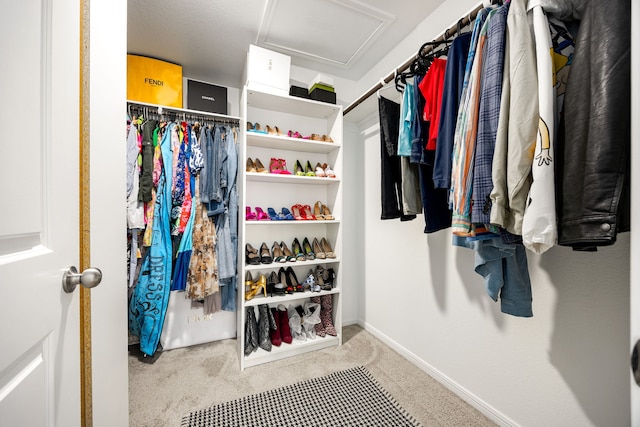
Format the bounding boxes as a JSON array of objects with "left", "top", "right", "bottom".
[{"left": 129, "top": 325, "right": 495, "bottom": 427}]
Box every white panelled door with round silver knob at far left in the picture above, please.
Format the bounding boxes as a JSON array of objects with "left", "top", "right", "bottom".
[{"left": 0, "top": 0, "right": 80, "bottom": 427}]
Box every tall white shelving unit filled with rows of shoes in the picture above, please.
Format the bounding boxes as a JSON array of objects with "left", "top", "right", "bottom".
[{"left": 237, "top": 88, "right": 343, "bottom": 370}]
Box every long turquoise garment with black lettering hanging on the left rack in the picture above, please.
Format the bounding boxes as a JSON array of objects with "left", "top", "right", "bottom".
[{"left": 129, "top": 123, "right": 176, "bottom": 356}]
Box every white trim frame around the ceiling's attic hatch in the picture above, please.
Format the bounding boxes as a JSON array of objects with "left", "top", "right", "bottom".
[{"left": 256, "top": 0, "right": 396, "bottom": 69}]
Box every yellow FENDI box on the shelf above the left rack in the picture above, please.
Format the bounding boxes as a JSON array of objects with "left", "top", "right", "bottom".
[{"left": 127, "top": 54, "right": 182, "bottom": 108}]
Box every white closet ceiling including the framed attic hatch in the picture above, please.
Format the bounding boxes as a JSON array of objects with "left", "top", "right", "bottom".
[{"left": 127, "top": 0, "right": 443, "bottom": 103}]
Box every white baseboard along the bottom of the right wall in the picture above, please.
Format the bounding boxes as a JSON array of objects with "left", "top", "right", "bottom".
[{"left": 360, "top": 321, "right": 519, "bottom": 427}]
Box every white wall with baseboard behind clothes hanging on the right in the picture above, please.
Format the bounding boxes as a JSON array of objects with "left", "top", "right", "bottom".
[{"left": 338, "top": 0, "right": 630, "bottom": 426}]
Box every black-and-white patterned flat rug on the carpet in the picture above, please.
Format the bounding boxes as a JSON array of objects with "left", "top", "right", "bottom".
[{"left": 181, "top": 366, "right": 420, "bottom": 427}]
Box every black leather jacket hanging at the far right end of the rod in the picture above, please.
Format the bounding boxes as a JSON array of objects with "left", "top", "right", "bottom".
[{"left": 541, "top": 0, "right": 631, "bottom": 250}]
